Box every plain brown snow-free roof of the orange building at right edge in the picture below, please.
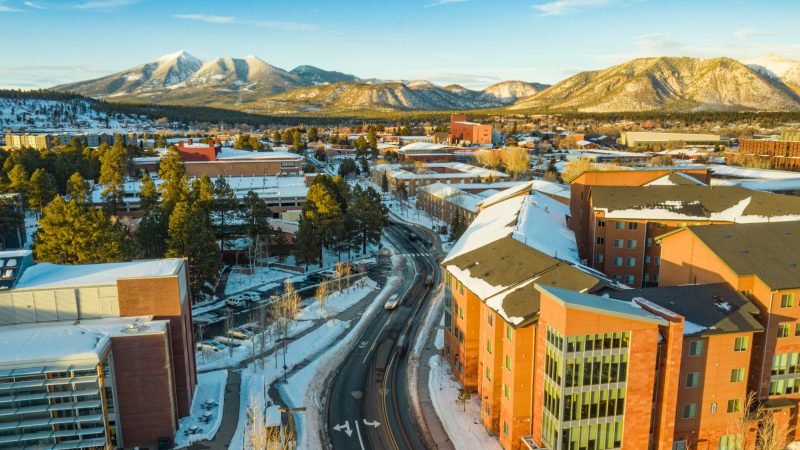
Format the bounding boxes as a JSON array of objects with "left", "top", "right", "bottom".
[{"left": 688, "top": 222, "right": 800, "bottom": 289}]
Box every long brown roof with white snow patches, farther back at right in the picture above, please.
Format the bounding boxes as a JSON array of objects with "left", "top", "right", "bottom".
[{"left": 590, "top": 185, "right": 800, "bottom": 223}]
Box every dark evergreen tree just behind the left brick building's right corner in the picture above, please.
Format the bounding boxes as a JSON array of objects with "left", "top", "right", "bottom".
[{"left": 165, "top": 201, "right": 222, "bottom": 299}]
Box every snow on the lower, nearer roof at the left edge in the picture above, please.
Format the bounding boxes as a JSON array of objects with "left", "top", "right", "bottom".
[{"left": 0, "top": 316, "right": 167, "bottom": 370}]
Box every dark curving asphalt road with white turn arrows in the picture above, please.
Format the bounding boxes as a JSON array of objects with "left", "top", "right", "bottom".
[{"left": 327, "top": 223, "right": 438, "bottom": 450}]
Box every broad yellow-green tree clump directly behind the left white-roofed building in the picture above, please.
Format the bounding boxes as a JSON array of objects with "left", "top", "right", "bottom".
[{"left": 33, "top": 196, "right": 135, "bottom": 264}]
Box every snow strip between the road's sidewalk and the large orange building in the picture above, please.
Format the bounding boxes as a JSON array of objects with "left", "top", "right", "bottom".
[{"left": 428, "top": 356, "right": 502, "bottom": 450}]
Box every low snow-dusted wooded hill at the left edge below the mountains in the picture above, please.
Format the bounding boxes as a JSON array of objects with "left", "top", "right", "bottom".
[{"left": 0, "top": 91, "right": 154, "bottom": 133}]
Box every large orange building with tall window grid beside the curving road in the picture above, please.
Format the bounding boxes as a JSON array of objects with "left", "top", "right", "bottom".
[{"left": 442, "top": 183, "right": 780, "bottom": 450}]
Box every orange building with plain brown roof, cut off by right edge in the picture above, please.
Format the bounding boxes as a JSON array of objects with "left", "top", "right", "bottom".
[{"left": 660, "top": 222, "right": 800, "bottom": 439}]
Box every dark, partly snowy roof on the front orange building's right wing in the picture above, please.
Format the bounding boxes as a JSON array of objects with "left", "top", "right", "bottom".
[{"left": 611, "top": 283, "right": 764, "bottom": 336}]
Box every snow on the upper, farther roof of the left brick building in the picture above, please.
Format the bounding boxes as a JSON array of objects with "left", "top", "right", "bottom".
[{"left": 14, "top": 258, "right": 183, "bottom": 290}]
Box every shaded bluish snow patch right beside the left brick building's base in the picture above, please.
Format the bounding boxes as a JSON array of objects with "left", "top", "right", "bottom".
[{"left": 175, "top": 370, "right": 228, "bottom": 448}]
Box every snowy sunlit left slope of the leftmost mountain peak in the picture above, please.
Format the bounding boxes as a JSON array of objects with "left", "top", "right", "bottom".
[{"left": 53, "top": 50, "right": 203, "bottom": 98}]
